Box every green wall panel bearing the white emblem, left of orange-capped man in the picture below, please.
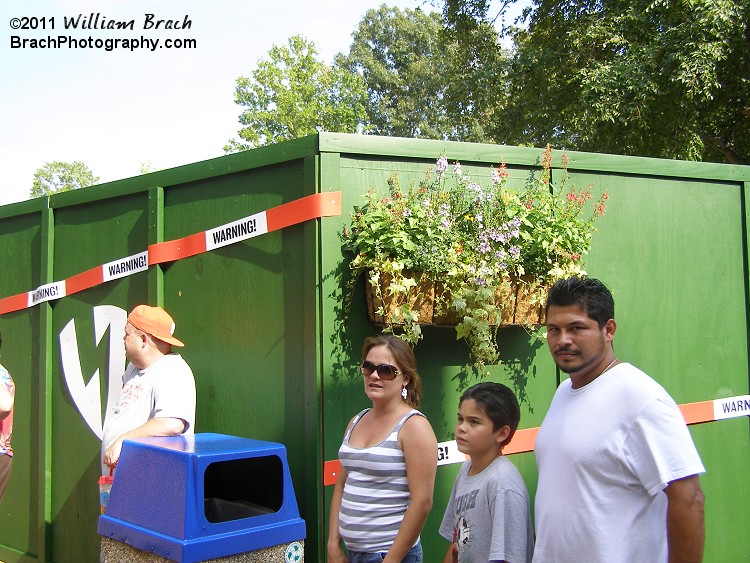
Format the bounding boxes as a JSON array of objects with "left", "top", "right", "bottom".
[{"left": 50, "top": 193, "right": 148, "bottom": 561}]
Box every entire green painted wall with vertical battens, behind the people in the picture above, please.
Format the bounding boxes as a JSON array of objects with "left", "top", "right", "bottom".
[{"left": 0, "top": 133, "right": 750, "bottom": 562}]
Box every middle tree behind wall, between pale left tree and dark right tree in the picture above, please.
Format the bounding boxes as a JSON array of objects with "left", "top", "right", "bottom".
[{"left": 336, "top": 5, "right": 506, "bottom": 141}]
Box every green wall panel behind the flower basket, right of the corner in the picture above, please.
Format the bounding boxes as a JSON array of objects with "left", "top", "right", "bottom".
[{"left": 322, "top": 155, "right": 557, "bottom": 561}]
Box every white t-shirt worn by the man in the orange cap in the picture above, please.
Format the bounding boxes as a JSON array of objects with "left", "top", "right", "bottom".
[{"left": 102, "top": 354, "right": 195, "bottom": 453}]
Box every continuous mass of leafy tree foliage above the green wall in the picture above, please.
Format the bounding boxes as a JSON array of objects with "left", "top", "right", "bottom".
[{"left": 225, "top": 0, "right": 750, "bottom": 163}]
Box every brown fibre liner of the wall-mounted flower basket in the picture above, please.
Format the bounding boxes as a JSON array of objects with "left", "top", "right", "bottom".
[{"left": 365, "top": 273, "right": 547, "bottom": 327}]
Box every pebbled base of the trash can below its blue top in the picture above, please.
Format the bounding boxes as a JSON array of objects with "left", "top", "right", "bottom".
[{"left": 100, "top": 537, "right": 305, "bottom": 563}]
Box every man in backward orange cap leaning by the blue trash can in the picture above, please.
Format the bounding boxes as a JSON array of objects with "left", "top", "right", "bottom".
[{"left": 102, "top": 305, "right": 195, "bottom": 467}]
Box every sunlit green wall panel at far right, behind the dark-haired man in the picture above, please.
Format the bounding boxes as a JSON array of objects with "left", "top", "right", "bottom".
[{"left": 583, "top": 171, "right": 750, "bottom": 561}]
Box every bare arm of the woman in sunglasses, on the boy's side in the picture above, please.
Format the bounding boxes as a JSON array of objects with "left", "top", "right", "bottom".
[{"left": 383, "top": 416, "right": 437, "bottom": 563}]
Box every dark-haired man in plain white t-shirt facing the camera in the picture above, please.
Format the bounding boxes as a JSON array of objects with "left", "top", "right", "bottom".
[{"left": 534, "top": 277, "right": 705, "bottom": 563}]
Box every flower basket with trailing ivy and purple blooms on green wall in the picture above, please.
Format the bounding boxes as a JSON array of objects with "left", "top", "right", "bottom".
[{"left": 342, "top": 147, "right": 607, "bottom": 368}]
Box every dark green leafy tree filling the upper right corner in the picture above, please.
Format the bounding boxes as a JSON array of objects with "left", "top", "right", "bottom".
[{"left": 444, "top": 0, "right": 750, "bottom": 163}]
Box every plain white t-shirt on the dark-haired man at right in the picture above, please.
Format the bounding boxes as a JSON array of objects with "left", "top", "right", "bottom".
[{"left": 534, "top": 364, "right": 705, "bottom": 563}]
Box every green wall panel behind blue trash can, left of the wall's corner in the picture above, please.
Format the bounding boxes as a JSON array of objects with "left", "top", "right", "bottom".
[{"left": 156, "top": 160, "right": 320, "bottom": 552}]
